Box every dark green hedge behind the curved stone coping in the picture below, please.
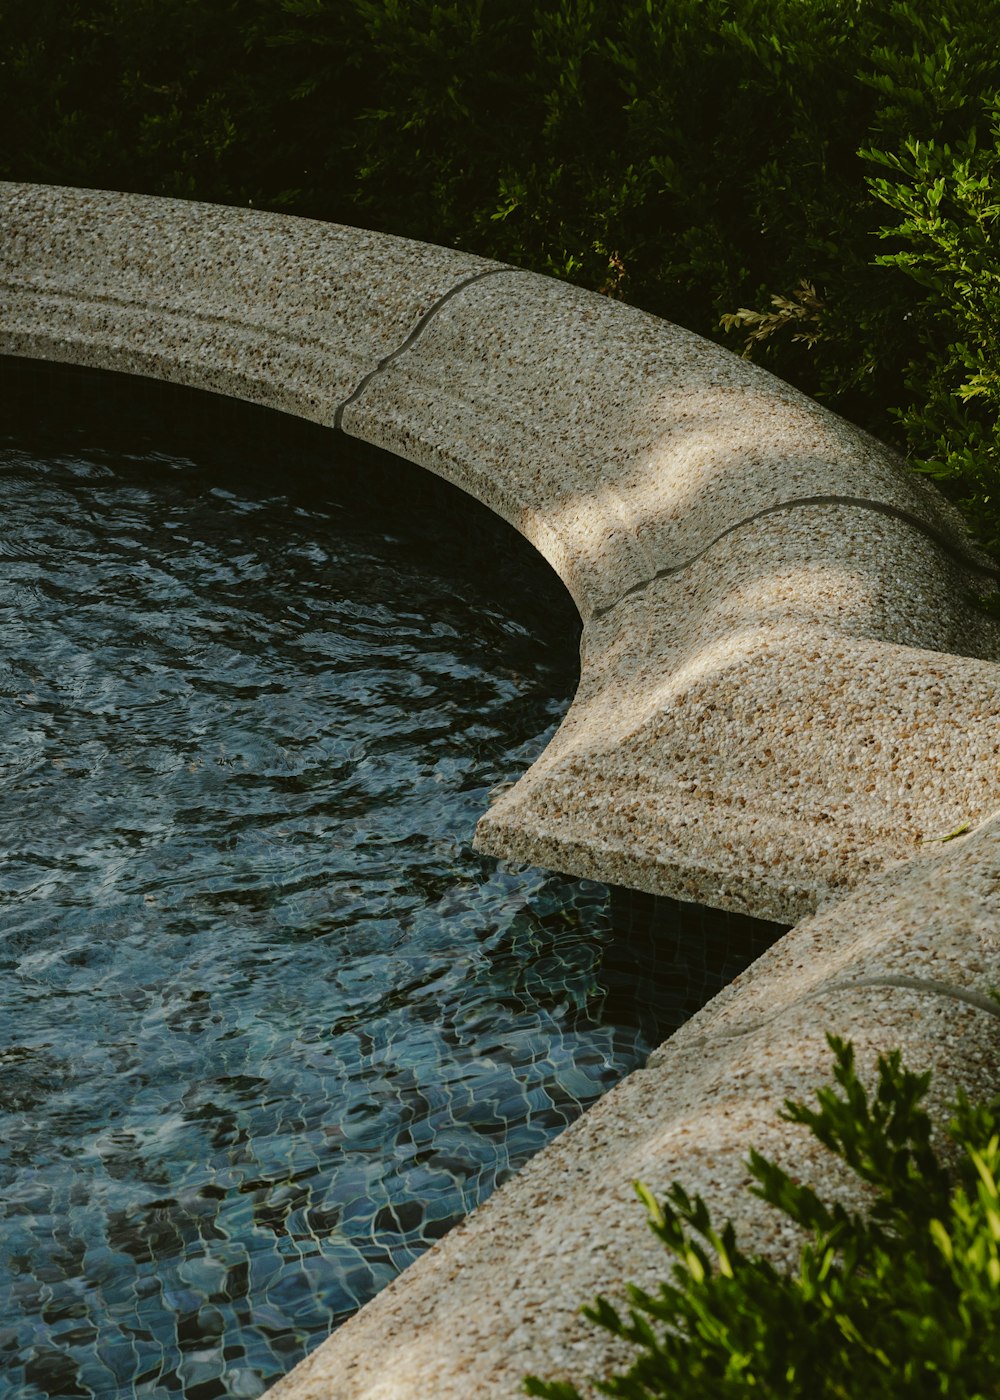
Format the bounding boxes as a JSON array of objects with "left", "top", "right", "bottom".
[{"left": 0, "top": 0, "right": 1000, "bottom": 554}]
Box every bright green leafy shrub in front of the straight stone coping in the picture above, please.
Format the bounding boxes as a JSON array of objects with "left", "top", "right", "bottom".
[{"left": 525, "top": 1037, "right": 1000, "bottom": 1400}]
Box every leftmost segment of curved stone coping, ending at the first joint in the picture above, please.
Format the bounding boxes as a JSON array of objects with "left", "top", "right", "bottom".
[{"left": 0, "top": 183, "right": 501, "bottom": 424}]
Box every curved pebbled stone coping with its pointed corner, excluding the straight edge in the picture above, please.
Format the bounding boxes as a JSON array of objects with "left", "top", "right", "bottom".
[{"left": 0, "top": 185, "right": 1000, "bottom": 921}]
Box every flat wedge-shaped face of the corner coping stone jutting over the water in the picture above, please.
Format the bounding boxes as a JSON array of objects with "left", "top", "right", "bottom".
[{"left": 479, "top": 627, "right": 1000, "bottom": 923}]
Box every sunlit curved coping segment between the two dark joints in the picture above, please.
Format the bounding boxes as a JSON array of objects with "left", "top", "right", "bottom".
[{"left": 338, "top": 264, "right": 979, "bottom": 617}]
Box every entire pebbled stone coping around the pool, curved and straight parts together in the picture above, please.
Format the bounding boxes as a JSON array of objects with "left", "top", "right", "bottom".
[{"left": 0, "top": 185, "right": 1000, "bottom": 1400}]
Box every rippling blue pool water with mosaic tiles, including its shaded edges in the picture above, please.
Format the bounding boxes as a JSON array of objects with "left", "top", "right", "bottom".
[{"left": 0, "top": 361, "right": 779, "bottom": 1400}]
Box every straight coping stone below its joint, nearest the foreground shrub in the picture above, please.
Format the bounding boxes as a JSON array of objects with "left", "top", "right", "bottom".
[{"left": 263, "top": 873, "right": 1000, "bottom": 1400}]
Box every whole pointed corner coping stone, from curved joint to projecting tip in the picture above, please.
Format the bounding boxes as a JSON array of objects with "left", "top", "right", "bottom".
[{"left": 479, "top": 505, "right": 1000, "bottom": 921}]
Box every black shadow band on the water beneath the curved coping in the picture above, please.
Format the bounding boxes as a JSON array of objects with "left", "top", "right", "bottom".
[{"left": 0, "top": 356, "right": 581, "bottom": 649}]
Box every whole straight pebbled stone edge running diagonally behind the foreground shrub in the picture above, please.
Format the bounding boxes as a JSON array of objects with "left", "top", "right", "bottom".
[{"left": 270, "top": 815, "right": 1000, "bottom": 1400}]
